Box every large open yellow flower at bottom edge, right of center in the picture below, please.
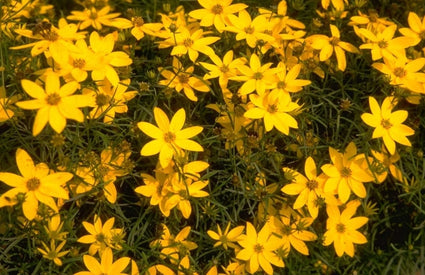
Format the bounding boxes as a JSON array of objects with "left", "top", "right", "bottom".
[{"left": 236, "top": 222, "right": 285, "bottom": 274}]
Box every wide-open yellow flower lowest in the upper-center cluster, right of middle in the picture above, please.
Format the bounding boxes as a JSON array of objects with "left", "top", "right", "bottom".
[{"left": 244, "top": 90, "right": 300, "bottom": 135}]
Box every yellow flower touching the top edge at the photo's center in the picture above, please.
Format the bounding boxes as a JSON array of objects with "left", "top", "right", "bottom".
[{"left": 189, "top": 0, "right": 248, "bottom": 32}]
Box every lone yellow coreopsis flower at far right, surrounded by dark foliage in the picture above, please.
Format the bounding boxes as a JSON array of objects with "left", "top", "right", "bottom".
[{"left": 361, "top": 97, "right": 415, "bottom": 155}]
